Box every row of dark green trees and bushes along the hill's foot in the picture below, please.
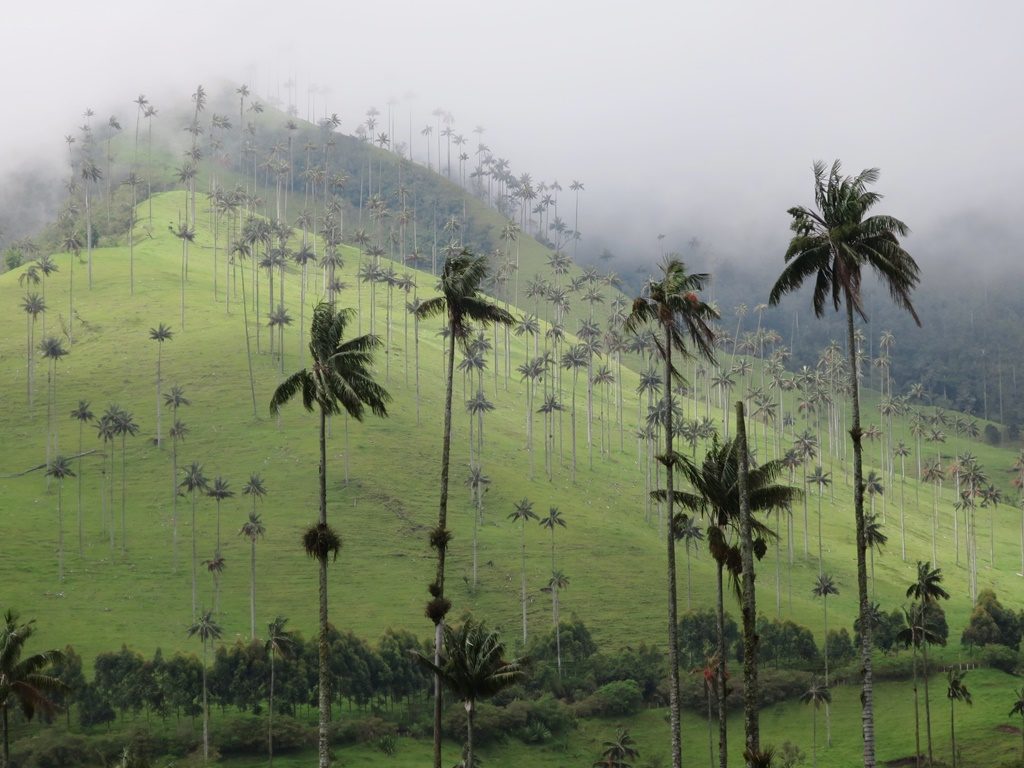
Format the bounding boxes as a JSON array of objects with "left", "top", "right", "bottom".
[{"left": 5, "top": 589, "right": 1024, "bottom": 763}]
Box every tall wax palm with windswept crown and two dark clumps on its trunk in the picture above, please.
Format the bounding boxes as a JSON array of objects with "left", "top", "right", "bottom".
[{"left": 416, "top": 249, "right": 514, "bottom": 768}]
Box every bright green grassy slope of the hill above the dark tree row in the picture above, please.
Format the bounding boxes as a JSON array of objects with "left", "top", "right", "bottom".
[{"left": 0, "top": 194, "right": 1020, "bottom": 765}]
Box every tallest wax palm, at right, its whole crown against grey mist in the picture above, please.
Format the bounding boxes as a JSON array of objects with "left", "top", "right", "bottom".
[{"left": 768, "top": 161, "right": 921, "bottom": 768}]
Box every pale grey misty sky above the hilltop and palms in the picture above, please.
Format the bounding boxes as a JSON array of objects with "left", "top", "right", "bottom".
[{"left": 0, "top": 0, "right": 1024, "bottom": 260}]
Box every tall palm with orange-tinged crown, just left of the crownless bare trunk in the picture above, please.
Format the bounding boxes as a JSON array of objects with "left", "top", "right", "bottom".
[{"left": 618, "top": 257, "right": 718, "bottom": 768}]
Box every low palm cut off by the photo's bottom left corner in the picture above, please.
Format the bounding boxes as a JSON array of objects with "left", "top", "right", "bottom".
[{"left": 0, "top": 609, "right": 66, "bottom": 768}]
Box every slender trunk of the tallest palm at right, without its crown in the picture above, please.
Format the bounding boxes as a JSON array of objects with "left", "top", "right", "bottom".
[{"left": 845, "top": 290, "right": 874, "bottom": 768}]
